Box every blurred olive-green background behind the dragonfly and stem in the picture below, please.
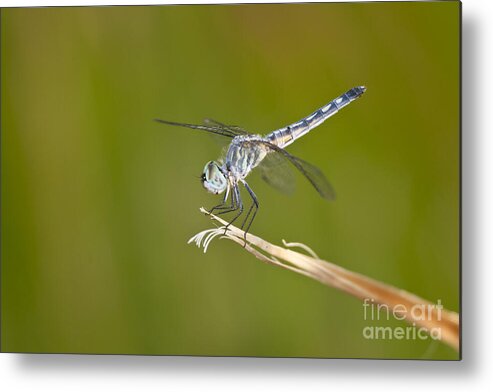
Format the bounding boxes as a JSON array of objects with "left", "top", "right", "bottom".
[{"left": 1, "top": 2, "right": 459, "bottom": 359}]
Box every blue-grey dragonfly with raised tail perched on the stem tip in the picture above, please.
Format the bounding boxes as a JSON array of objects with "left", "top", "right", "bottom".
[{"left": 154, "top": 86, "right": 366, "bottom": 239}]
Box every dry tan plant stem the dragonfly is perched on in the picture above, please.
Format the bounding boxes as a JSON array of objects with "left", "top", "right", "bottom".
[{"left": 195, "top": 208, "right": 459, "bottom": 350}]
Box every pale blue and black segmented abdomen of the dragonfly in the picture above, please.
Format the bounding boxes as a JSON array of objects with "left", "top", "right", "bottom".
[{"left": 266, "top": 86, "right": 366, "bottom": 148}]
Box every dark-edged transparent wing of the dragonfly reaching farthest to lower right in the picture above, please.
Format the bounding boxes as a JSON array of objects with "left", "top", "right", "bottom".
[{"left": 260, "top": 141, "right": 335, "bottom": 200}]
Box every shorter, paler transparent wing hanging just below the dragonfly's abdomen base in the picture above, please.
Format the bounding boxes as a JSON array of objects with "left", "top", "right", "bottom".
[{"left": 256, "top": 153, "right": 296, "bottom": 195}]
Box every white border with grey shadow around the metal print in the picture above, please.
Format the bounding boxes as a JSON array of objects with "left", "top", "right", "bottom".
[{"left": 0, "top": 0, "right": 493, "bottom": 392}]
